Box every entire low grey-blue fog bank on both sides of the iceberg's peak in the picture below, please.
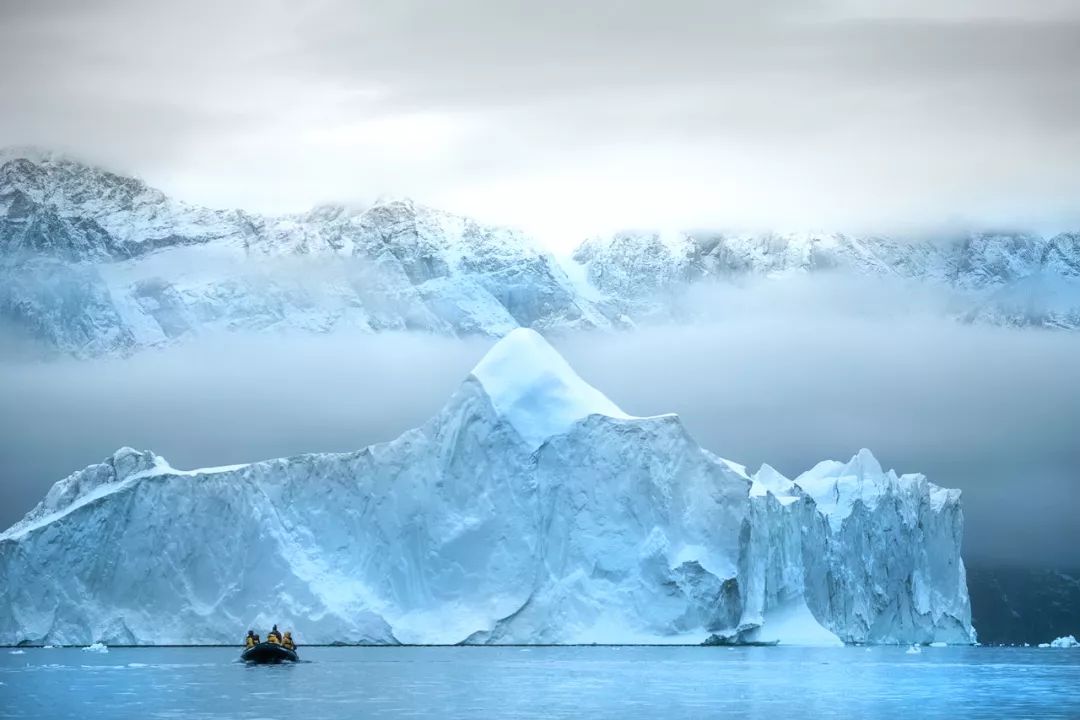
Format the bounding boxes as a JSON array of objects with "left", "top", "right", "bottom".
[{"left": 0, "top": 313, "right": 1080, "bottom": 567}]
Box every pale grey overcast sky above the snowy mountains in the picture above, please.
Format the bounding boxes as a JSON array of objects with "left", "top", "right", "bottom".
[{"left": 0, "top": 0, "right": 1080, "bottom": 246}]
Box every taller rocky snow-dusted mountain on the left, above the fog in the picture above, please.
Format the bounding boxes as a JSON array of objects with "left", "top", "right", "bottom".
[{"left": 0, "top": 154, "right": 609, "bottom": 356}]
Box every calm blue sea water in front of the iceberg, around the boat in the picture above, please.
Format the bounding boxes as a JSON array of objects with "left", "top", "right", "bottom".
[{"left": 0, "top": 647, "right": 1080, "bottom": 720}]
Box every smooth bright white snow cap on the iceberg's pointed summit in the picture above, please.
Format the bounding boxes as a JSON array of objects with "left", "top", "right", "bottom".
[{"left": 471, "top": 327, "right": 632, "bottom": 447}]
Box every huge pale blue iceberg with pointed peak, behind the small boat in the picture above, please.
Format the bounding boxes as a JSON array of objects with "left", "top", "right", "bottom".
[{"left": 0, "top": 329, "right": 974, "bottom": 644}]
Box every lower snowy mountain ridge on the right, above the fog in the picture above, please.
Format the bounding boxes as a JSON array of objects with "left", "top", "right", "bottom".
[{"left": 573, "top": 232, "right": 1080, "bottom": 329}]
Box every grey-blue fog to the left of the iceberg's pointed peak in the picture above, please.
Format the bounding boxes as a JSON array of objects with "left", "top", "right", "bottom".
[{"left": 0, "top": 332, "right": 490, "bottom": 528}]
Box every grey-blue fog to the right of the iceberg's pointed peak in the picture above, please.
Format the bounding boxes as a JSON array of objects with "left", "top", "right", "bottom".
[{"left": 562, "top": 320, "right": 1080, "bottom": 568}]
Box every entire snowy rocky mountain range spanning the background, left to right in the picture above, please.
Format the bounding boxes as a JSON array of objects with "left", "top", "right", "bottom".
[{"left": 0, "top": 152, "right": 1080, "bottom": 357}]
